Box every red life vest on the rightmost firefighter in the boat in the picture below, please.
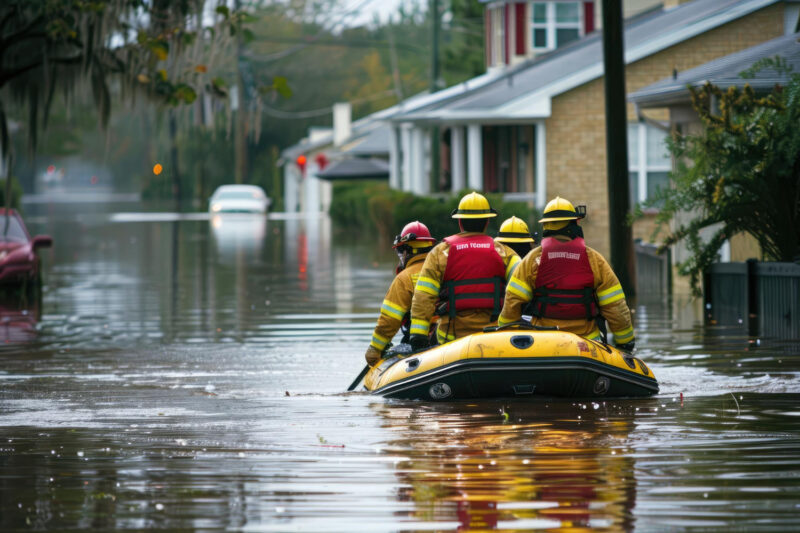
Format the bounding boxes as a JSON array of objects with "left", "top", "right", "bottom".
[{"left": 528, "top": 237, "right": 598, "bottom": 320}]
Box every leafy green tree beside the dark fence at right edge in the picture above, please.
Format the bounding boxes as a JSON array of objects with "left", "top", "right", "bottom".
[{"left": 651, "top": 59, "right": 800, "bottom": 294}]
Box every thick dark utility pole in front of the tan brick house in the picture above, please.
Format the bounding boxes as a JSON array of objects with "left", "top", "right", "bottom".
[{"left": 603, "top": 0, "right": 636, "bottom": 298}]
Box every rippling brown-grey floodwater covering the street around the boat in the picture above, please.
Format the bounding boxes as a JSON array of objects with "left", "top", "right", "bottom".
[{"left": 0, "top": 205, "right": 800, "bottom": 532}]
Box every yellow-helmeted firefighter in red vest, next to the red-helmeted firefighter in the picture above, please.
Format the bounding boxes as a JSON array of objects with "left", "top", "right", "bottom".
[{"left": 410, "top": 192, "right": 519, "bottom": 349}]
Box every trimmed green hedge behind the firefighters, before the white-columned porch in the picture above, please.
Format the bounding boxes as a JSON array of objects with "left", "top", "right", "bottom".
[{"left": 330, "top": 181, "right": 540, "bottom": 242}]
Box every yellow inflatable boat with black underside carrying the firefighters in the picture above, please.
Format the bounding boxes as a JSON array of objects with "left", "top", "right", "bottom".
[{"left": 364, "top": 325, "right": 658, "bottom": 400}]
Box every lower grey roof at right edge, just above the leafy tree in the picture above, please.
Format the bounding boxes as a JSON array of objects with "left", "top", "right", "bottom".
[{"left": 628, "top": 32, "right": 800, "bottom": 108}]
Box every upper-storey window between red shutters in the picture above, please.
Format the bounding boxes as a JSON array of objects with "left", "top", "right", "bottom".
[{"left": 531, "top": 2, "right": 583, "bottom": 51}]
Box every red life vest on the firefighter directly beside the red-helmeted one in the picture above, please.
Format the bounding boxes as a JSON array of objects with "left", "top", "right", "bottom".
[{"left": 440, "top": 235, "right": 506, "bottom": 318}]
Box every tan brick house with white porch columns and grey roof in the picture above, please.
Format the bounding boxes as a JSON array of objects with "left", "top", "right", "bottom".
[{"left": 386, "top": 0, "right": 800, "bottom": 254}]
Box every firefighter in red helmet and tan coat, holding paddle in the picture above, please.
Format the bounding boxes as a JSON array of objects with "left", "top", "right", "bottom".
[{"left": 364, "top": 221, "right": 436, "bottom": 366}]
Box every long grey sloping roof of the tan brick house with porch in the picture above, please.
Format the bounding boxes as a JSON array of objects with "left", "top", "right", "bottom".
[{"left": 391, "top": 0, "right": 779, "bottom": 122}]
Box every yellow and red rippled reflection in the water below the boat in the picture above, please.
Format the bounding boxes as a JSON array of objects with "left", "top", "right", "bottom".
[{"left": 373, "top": 401, "right": 636, "bottom": 531}]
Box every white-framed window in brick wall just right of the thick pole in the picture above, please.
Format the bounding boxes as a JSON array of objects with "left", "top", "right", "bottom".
[{"left": 628, "top": 122, "right": 672, "bottom": 206}]
